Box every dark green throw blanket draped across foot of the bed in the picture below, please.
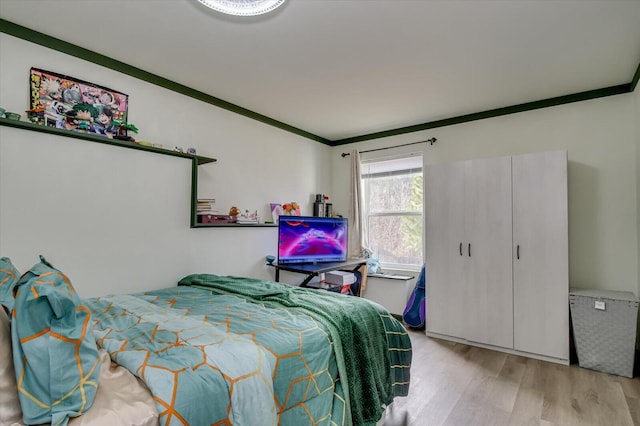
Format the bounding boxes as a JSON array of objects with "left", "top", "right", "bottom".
[{"left": 178, "top": 274, "right": 411, "bottom": 425}]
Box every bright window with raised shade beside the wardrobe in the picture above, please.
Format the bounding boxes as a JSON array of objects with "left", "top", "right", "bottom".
[{"left": 361, "top": 154, "right": 424, "bottom": 269}]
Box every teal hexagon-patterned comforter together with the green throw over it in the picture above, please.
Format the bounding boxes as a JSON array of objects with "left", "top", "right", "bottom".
[{"left": 86, "top": 275, "right": 411, "bottom": 425}]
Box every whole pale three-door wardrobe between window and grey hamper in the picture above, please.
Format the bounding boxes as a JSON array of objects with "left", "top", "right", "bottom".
[{"left": 425, "top": 151, "right": 569, "bottom": 364}]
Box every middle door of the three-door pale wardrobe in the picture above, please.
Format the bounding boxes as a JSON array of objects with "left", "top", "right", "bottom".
[{"left": 464, "top": 157, "right": 513, "bottom": 348}]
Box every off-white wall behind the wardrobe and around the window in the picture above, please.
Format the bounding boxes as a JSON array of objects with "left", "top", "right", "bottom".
[{"left": 331, "top": 90, "right": 640, "bottom": 294}]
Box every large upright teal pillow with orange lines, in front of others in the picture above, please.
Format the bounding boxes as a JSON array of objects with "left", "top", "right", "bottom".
[{"left": 11, "top": 257, "right": 100, "bottom": 425}]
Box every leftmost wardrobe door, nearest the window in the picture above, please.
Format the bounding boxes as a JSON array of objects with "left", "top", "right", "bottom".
[{"left": 425, "top": 163, "right": 467, "bottom": 338}]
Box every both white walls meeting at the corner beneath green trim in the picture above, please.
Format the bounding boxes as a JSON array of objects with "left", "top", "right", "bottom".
[{"left": 0, "top": 34, "right": 640, "bottom": 296}]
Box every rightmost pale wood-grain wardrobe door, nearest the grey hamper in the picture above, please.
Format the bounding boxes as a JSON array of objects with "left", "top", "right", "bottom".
[{"left": 513, "top": 151, "right": 569, "bottom": 360}]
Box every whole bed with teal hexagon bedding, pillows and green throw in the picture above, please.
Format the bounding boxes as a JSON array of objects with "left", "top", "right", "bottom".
[{"left": 0, "top": 256, "right": 411, "bottom": 425}]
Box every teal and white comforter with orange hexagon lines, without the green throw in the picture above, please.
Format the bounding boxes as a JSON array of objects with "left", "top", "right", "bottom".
[{"left": 86, "top": 287, "right": 337, "bottom": 425}]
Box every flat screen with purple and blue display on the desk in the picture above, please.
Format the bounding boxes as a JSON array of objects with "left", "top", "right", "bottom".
[{"left": 278, "top": 216, "right": 348, "bottom": 264}]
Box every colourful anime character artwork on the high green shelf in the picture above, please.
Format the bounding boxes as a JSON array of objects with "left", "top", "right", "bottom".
[{"left": 29, "top": 68, "right": 129, "bottom": 138}]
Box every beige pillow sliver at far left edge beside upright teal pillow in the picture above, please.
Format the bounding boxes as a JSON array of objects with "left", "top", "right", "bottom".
[{"left": 0, "top": 306, "right": 22, "bottom": 425}]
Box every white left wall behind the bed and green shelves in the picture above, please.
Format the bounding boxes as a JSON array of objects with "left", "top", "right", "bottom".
[{"left": 0, "top": 34, "right": 331, "bottom": 297}]
